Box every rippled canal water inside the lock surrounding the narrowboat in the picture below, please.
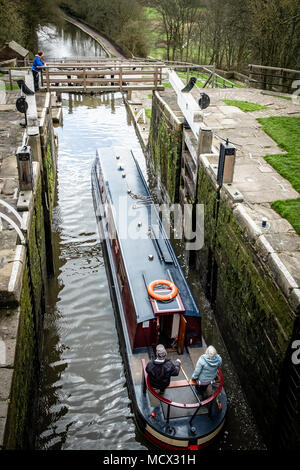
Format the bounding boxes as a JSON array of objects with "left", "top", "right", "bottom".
[{"left": 34, "top": 20, "right": 263, "bottom": 450}]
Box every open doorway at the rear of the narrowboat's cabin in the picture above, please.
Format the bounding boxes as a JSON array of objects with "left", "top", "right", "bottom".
[{"left": 157, "top": 313, "right": 187, "bottom": 354}]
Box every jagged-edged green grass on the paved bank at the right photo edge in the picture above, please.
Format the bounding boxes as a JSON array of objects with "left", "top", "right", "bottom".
[{"left": 258, "top": 116, "right": 300, "bottom": 234}]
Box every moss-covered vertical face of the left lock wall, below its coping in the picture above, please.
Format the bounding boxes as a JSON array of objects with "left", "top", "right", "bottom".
[{"left": 4, "top": 113, "right": 56, "bottom": 450}]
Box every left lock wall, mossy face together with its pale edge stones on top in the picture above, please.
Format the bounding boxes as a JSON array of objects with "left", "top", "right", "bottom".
[{"left": 0, "top": 92, "right": 56, "bottom": 450}]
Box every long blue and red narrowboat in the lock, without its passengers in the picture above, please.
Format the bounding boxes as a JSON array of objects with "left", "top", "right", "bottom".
[{"left": 91, "top": 148, "right": 227, "bottom": 450}]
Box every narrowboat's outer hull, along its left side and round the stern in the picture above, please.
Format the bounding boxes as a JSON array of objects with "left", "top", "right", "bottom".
[{"left": 92, "top": 152, "right": 227, "bottom": 450}]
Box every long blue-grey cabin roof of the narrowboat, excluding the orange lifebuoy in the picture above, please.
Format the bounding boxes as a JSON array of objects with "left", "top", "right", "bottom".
[{"left": 97, "top": 148, "right": 201, "bottom": 323}]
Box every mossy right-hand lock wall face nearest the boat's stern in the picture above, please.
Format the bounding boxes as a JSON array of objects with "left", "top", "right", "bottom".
[{"left": 194, "top": 161, "right": 299, "bottom": 446}]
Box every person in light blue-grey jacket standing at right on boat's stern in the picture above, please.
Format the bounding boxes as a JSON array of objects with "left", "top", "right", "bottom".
[{"left": 192, "top": 346, "right": 222, "bottom": 393}]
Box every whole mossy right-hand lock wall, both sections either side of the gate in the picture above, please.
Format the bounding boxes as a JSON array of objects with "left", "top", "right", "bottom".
[{"left": 150, "top": 93, "right": 300, "bottom": 449}]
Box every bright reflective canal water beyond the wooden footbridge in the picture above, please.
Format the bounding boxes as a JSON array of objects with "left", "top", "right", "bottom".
[{"left": 38, "top": 21, "right": 106, "bottom": 62}]
